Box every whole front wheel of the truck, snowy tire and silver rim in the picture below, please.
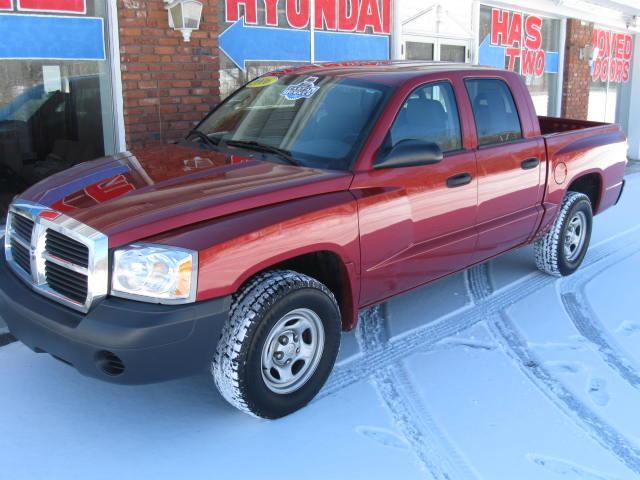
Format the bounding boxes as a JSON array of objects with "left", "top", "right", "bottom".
[{"left": 212, "top": 270, "right": 341, "bottom": 419}]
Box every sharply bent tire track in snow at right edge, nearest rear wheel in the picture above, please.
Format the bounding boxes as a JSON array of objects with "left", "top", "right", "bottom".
[{"left": 559, "top": 247, "right": 640, "bottom": 390}]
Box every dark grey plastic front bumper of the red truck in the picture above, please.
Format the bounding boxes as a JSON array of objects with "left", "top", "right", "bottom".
[{"left": 0, "top": 255, "right": 231, "bottom": 384}]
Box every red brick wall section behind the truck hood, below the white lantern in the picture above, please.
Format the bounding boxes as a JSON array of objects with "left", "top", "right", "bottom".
[{"left": 118, "top": 0, "right": 220, "bottom": 148}]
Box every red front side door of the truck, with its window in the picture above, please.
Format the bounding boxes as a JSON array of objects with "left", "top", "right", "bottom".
[{"left": 352, "top": 81, "right": 478, "bottom": 306}]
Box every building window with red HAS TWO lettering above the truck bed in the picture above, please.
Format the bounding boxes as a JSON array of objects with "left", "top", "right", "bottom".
[{"left": 478, "top": 5, "right": 561, "bottom": 115}]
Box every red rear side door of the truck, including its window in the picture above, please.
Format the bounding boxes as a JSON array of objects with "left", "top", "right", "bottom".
[{"left": 465, "top": 78, "right": 545, "bottom": 262}]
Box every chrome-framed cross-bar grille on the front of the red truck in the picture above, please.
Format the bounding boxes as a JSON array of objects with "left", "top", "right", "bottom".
[{"left": 5, "top": 201, "right": 108, "bottom": 312}]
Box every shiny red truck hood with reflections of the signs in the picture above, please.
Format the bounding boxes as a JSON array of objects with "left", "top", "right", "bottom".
[{"left": 20, "top": 144, "right": 352, "bottom": 248}]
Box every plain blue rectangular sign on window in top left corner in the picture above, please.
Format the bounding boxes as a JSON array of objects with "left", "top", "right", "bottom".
[{"left": 0, "top": 14, "right": 105, "bottom": 60}]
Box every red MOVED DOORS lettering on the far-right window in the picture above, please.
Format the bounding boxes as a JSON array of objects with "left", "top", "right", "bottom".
[{"left": 591, "top": 29, "right": 633, "bottom": 83}]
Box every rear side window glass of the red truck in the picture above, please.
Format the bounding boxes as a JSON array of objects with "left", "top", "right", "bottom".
[{"left": 465, "top": 79, "right": 522, "bottom": 146}]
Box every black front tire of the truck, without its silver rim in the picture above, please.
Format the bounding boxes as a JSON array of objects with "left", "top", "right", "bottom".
[{"left": 211, "top": 270, "right": 342, "bottom": 419}]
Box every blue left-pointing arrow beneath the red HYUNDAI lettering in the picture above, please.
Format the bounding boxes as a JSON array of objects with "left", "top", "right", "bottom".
[{"left": 219, "top": 17, "right": 389, "bottom": 70}]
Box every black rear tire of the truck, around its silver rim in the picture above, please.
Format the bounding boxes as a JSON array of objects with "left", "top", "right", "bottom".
[{"left": 534, "top": 192, "right": 593, "bottom": 277}]
